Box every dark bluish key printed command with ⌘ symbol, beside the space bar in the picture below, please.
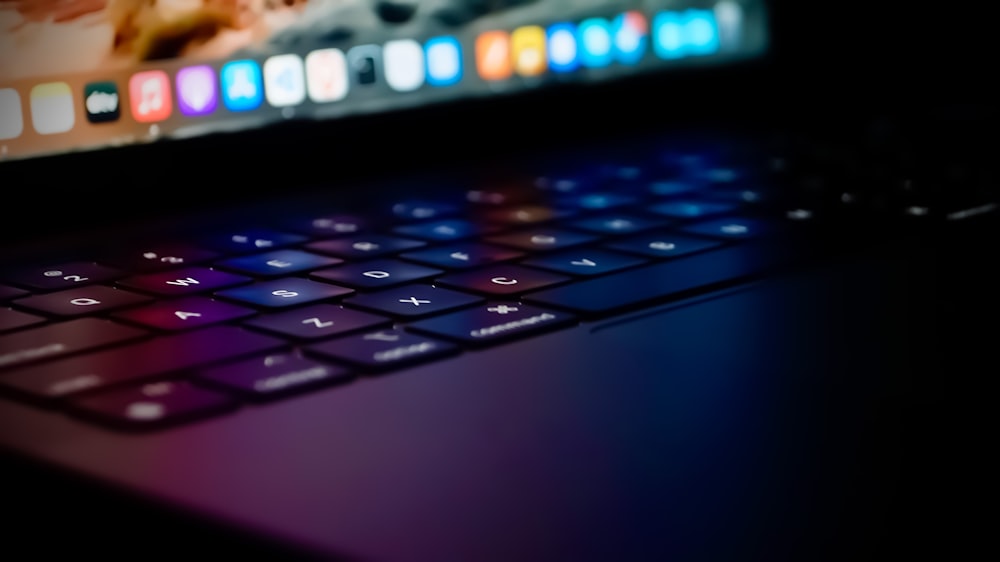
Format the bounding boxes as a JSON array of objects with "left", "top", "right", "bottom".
[{"left": 409, "top": 303, "right": 575, "bottom": 346}]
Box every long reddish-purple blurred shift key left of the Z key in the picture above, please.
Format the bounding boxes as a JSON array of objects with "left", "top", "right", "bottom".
[{"left": 0, "top": 322, "right": 286, "bottom": 400}]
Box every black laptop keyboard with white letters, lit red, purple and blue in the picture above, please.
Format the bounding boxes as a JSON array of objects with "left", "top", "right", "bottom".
[{"left": 0, "top": 129, "right": 996, "bottom": 430}]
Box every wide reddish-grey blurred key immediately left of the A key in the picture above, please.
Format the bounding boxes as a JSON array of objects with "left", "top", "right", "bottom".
[{"left": 0, "top": 318, "right": 148, "bottom": 369}]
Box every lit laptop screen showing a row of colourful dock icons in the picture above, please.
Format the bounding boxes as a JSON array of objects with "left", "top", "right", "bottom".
[{"left": 0, "top": 0, "right": 766, "bottom": 159}]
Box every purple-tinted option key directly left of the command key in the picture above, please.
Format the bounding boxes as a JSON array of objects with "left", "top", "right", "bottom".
[{"left": 306, "top": 330, "right": 460, "bottom": 371}]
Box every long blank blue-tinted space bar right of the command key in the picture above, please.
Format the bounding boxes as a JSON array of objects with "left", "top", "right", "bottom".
[{"left": 524, "top": 244, "right": 785, "bottom": 315}]
